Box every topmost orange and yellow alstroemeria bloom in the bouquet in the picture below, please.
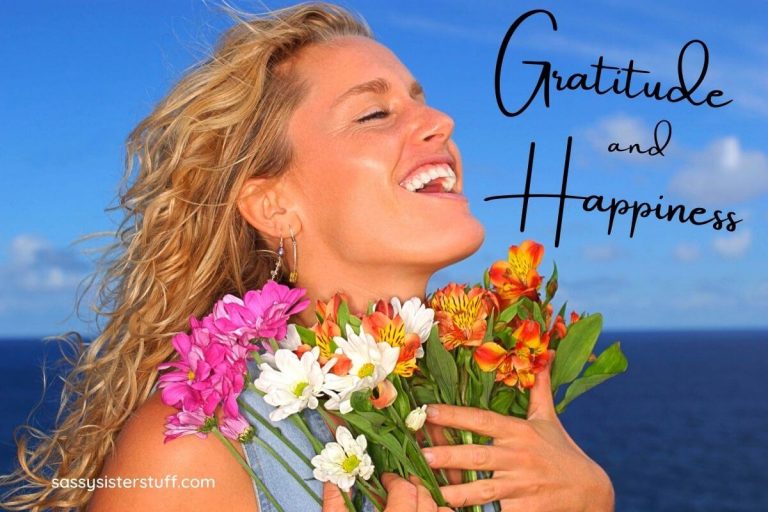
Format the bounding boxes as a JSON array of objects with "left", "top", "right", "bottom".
[{"left": 488, "top": 240, "right": 544, "bottom": 308}]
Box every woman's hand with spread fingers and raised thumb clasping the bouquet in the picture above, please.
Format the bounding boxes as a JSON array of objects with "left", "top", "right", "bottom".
[{"left": 423, "top": 352, "right": 614, "bottom": 512}]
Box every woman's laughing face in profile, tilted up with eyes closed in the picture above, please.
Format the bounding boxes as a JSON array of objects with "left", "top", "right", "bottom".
[{"left": 286, "top": 37, "right": 484, "bottom": 271}]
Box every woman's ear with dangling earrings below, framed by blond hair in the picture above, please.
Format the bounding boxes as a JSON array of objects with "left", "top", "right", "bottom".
[{"left": 237, "top": 178, "right": 301, "bottom": 240}]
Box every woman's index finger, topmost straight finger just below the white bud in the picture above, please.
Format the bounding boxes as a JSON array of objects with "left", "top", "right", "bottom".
[{"left": 427, "top": 404, "right": 525, "bottom": 437}]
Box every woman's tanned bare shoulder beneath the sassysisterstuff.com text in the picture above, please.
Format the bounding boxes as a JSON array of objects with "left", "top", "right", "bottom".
[{"left": 88, "top": 393, "right": 258, "bottom": 512}]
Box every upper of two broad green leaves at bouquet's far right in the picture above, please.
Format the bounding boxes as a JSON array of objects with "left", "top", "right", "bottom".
[{"left": 552, "top": 313, "right": 603, "bottom": 391}]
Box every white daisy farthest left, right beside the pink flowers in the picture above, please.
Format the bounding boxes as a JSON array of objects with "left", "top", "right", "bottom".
[{"left": 254, "top": 347, "right": 325, "bottom": 421}]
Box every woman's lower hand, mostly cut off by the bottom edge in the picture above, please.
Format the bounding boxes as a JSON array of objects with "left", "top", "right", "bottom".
[{"left": 323, "top": 473, "right": 451, "bottom": 512}]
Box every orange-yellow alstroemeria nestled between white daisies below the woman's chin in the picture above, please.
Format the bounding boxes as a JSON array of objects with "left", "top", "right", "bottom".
[{"left": 361, "top": 300, "right": 421, "bottom": 377}]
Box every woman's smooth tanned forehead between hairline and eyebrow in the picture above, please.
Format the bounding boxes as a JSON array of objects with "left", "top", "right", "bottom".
[{"left": 294, "top": 36, "right": 413, "bottom": 102}]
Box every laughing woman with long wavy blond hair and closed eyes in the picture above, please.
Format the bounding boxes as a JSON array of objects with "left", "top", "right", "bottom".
[{"left": 1, "top": 4, "right": 613, "bottom": 511}]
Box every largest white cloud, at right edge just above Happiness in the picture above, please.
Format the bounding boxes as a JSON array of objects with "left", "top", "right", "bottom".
[{"left": 669, "top": 137, "right": 768, "bottom": 205}]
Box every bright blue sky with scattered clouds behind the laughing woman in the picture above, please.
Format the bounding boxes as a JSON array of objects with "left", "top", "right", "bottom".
[{"left": 0, "top": 0, "right": 768, "bottom": 336}]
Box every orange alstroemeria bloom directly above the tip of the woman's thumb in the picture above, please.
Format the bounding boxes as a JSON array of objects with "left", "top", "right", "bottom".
[{"left": 474, "top": 320, "right": 549, "bottom": 390}]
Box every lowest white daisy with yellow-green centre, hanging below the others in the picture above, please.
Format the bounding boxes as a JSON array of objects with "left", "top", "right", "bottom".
[{"left": 312, "top": 427, "right": 374, "bottom": 492}]
